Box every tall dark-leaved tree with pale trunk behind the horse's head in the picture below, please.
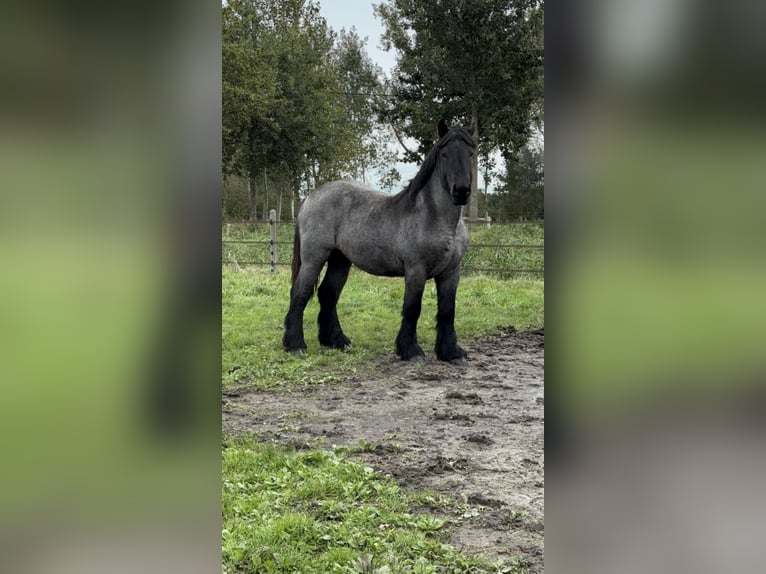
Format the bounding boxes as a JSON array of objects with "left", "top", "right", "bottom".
[{"left": 375, "top": 0, "right": 544, "bottom": 218}]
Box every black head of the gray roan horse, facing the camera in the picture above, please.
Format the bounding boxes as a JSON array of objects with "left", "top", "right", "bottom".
[{"left": 438, "top": 120, "right": 475, "bottom": 205}]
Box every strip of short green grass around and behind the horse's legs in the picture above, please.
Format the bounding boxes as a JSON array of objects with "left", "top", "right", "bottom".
[{"left": 221, "top": 267, "right": 543, "bottom": 388}]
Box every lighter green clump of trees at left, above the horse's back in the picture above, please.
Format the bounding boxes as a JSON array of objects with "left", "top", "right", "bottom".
[{"left": 222, "top": 0, "right": 386, "bottom": 219}]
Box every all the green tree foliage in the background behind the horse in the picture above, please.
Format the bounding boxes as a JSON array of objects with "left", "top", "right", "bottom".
[{"left": 222, "top": 0, "right": 544, "bottom": 220}]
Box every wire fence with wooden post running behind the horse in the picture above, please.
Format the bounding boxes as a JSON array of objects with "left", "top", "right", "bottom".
[{"left": 221, "top": 213, "right": 545, "bottom": 278}]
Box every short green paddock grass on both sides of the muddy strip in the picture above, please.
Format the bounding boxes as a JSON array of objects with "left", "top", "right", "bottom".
[{"left": 221, "top": 250, "right": 543, "bottom": 574}]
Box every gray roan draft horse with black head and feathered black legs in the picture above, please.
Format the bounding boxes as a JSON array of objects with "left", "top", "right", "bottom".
[{"left": 283, "top": 120, "right": 474, "bottom": 364}]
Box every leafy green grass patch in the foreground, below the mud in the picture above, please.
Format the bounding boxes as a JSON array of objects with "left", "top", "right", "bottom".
[{"left": 222, "top": 439, "right": 524, "bottom": 574}]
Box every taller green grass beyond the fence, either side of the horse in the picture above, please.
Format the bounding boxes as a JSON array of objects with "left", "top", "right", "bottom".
[{"left": 222, "top": 223, "right": 544, "bottom": 279}]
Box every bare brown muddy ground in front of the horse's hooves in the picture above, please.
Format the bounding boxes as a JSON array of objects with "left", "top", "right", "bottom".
[{"left": 223, "top": 327, "right": 544, "bottom": 573}]
